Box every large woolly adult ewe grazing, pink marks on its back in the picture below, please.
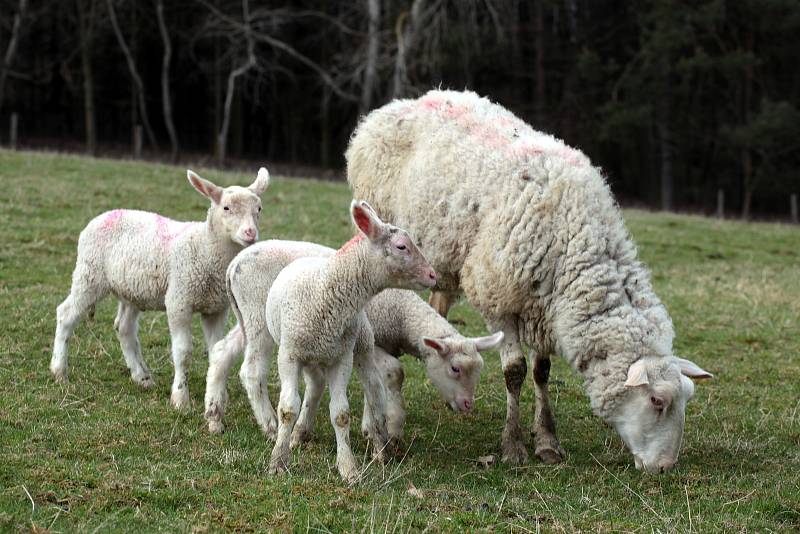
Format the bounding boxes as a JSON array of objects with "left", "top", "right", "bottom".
[{"left": 346, "top": 91, "right": 711, "bottom": 472}]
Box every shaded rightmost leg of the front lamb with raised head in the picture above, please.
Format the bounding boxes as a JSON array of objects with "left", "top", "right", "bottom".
[{"left": 353, "top": 336, "right": 395, "bottom": 462}]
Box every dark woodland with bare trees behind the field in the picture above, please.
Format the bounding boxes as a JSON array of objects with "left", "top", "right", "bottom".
[{"left": 0, "top": 0, "right": 800, "bottom": 218}]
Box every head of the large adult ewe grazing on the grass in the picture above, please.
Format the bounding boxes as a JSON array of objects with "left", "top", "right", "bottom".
[{"left": 608, "top": 357, "right": 712, "bottom": 473}]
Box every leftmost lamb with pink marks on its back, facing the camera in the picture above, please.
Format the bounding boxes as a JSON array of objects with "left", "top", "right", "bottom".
[{"left": 50, "top": 167, "right": 269, "bottom": 410}]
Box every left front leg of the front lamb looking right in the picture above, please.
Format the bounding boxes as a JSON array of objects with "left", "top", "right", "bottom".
[{"left": 269, "top": 356, "right": 301, "bottom": 475}]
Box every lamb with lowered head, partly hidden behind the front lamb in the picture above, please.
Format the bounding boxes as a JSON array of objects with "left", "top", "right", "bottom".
[{"left": 205, "top": 240, "right": 502, "bottom": 445}]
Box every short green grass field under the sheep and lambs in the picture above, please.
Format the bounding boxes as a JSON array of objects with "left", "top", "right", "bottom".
[{"left": 0, "top": 151, "right": 800, "bottom": 532}]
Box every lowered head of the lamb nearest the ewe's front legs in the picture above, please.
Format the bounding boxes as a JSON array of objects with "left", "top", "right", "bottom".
[{"left": 422, "top": 332, "right": 503, "bottom": 413}]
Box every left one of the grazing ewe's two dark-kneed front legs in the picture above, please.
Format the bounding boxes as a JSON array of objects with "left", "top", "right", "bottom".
[{"left": 490, "top": 317, "right": 528, "bottom": 465}]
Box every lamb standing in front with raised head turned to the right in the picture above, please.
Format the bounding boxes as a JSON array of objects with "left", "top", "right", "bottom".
[{"left": 266, "top": 201, "right": 436, "bottom": 482}]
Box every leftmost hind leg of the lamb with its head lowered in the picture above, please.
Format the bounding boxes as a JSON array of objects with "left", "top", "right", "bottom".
[{"left": 205, "top": 325, "right": 244, "bottom": 434}]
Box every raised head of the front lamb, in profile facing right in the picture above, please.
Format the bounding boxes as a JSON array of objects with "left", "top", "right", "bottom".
[{"left": 350, "top": 200, "right": 436, "bottom": 289}]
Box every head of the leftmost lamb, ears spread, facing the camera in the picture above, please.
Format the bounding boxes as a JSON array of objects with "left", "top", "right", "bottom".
[{"left": 186, "top": 167, "right": 269, "bottom": 247}]
